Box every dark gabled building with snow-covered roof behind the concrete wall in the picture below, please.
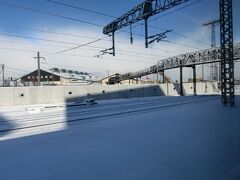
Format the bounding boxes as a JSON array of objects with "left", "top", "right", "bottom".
[{"left": 17, "top": 68, "right": 98, "bottom": 86}]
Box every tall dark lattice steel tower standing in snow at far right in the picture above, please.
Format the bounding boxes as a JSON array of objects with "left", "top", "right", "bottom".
[{"left": 220, "top": 0, "right": 235, "bottom": 106}]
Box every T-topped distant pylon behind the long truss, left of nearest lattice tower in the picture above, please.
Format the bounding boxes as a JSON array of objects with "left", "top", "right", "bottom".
[{"left": 203, "top": 19, "right": 220, "bottom": 80}]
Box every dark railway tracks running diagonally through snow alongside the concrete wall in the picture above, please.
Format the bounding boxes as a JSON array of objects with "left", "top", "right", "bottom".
[{"left": 0, "top": 96, "right": 218, "bottom": 139}]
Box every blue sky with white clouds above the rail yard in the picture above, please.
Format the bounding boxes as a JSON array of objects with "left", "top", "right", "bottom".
[{"left": 0, "top": 0, "right": 240, "bottom": 79}]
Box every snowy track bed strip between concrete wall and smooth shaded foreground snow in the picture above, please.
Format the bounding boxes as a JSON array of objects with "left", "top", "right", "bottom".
[{"left": 0, "top": 96, "right": 216, "bottom": 141}]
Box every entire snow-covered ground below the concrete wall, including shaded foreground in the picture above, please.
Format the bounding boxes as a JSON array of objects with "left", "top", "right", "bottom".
[{"left": 0, "top": 96, "right": 240, "bottom": 180}]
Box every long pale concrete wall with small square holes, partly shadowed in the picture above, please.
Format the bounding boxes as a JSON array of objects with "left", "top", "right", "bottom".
[{"left": 0, "top": 83, "right": 220, "bottom": 106}]
